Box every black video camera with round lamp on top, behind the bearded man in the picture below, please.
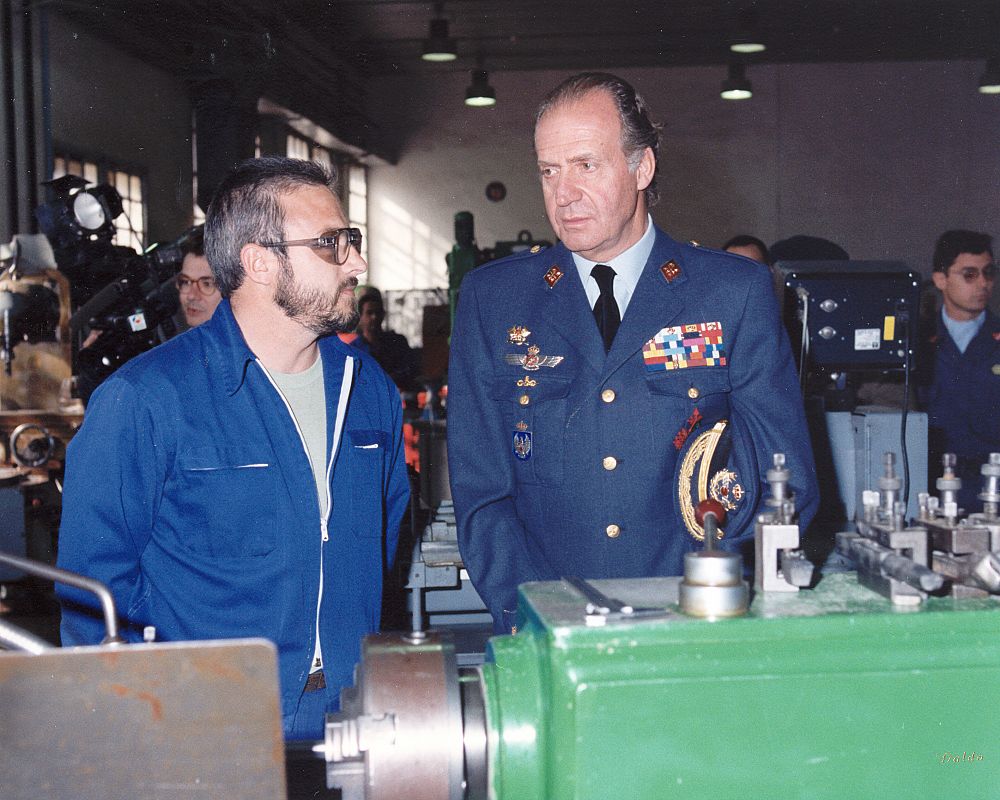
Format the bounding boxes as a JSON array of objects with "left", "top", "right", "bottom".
[{"left": 35, "top": 175, "right": 198, "bottom": 403}]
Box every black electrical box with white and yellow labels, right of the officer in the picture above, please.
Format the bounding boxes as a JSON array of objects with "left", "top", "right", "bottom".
[{"left": 775, "top": 261, "right": 921, "bottom": 373}]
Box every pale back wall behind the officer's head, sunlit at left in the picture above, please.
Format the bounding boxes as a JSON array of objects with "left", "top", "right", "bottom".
[{"left": 369, "top": 62, "right": 1000, "bottom": 296}]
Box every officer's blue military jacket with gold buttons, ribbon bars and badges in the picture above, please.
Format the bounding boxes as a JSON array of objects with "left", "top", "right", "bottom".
[{"left": 448, "top": 230, "right": 818, "bottom": 630}]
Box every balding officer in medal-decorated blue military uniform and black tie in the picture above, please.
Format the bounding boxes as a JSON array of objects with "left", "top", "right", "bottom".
[{"left": 448, "top": 73, "right": 817, "bottom": 631}]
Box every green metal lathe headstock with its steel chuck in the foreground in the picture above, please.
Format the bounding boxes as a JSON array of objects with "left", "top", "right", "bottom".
[{"left": 321, "top": 573, "right": 1000, "bottom": 800}]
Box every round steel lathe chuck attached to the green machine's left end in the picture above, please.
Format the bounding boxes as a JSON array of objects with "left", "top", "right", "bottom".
[{"left": 316, "top": 632, "right": 486, "bottom": 800}]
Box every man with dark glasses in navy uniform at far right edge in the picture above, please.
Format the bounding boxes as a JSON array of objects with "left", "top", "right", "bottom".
[{"left": 924, "top": 230, "right": 1000, "bottom": 512}]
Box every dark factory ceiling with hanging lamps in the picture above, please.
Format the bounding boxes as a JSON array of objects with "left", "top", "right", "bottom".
[{"left": 52, "top": 0, "right": 1000, "bottom": 155}]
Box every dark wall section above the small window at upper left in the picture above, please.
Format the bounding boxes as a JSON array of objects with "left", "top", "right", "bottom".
[{"left": 48, "top": 14, "right": 193, "bottom": 241}]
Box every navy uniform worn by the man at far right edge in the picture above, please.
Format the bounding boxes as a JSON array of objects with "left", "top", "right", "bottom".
[{"left": 927, "top": 311, "right": 1000, "bottom": 511}]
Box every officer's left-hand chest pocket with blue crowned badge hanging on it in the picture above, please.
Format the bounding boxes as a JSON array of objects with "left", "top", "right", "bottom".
[{"left": 490, "top": 372, "right": 571, "bottom": 486}]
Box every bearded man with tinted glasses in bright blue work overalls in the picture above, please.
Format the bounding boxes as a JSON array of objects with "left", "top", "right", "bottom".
[{"left": 57, "top": 158, "right": 409, "bottom": 739}]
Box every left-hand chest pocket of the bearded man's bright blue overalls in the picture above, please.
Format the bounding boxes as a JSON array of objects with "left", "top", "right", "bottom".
[{"left": 176, "top": 447, "right": 282, "bottom": 558}]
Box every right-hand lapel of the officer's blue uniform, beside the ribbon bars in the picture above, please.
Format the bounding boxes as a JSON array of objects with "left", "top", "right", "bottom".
[{"left": 595, "top": 229, "right": 688, "bottom": 378}]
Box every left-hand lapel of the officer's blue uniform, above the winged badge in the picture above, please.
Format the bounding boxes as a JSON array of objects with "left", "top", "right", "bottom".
[{"left": 537, "top": 242, "right": 605, "bottom": 372}]
